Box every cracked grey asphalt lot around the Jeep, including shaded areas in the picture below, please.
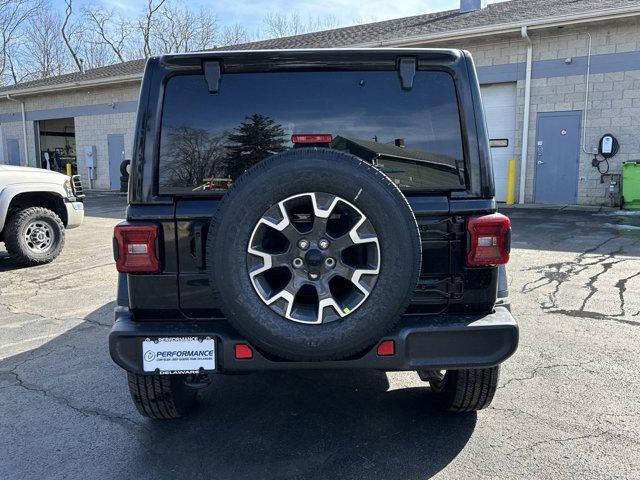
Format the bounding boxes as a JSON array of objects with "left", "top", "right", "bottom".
[{"left": 0, "top": 195, "right": 640, "bottom": 480}]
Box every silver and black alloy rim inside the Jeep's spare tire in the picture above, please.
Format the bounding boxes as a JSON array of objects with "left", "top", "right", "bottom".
[{"left": 247, "top": 192, "right": 380, "bottom": 324}]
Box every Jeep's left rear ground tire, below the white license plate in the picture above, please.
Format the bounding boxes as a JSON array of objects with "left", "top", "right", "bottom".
[{"left": 127, "top": 372, "right": 198, "bottom": 420}]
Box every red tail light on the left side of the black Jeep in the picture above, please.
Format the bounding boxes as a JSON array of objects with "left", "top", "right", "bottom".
[{"left": 113, "top": 224, "right": 160, "bottom": 273}]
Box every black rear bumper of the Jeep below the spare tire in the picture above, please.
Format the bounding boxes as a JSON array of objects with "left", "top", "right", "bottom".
[{"left": 109, "top": 307, "right": 518, "bottom": 374}]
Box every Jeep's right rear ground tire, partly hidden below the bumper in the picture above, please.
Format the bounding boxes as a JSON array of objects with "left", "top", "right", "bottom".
[{"left": 429, "top": 365, "right": 500, "bottom": 412}]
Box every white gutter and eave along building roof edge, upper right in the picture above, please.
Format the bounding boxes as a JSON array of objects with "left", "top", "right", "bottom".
[{"left": 353, "top": 5, "right": 640, "bottom": 47}]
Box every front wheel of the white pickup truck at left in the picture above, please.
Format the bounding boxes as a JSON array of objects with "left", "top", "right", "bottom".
[{"left": 4, "top": 207, "right": 64, "bottom": 265}]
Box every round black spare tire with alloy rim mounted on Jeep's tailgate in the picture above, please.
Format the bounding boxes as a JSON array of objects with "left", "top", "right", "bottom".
[{"left": 207, "top": 148, "right": 421, "bottom": 361}]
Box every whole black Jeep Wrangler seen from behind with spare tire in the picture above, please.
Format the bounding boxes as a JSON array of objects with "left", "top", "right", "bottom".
[{"left": 109, "top": 49, "right": 518, "bottom": 418}]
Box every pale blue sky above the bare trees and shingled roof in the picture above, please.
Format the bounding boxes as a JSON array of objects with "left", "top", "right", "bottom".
[{"left": 71, "top": 0, "right": 502, "bottom": 35}]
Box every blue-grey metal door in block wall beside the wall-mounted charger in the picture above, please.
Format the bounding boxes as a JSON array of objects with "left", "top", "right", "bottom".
[{"left": 534, "top": 111, "right": 582, "bottom": 204}]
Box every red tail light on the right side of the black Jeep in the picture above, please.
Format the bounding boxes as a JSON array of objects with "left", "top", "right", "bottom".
[{"left": 467, "top": 213, "right": 511, "bottom": 267}]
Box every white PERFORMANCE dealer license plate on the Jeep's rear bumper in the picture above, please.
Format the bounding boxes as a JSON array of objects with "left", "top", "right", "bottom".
[{"left": 142, "top": 337, "right": 216, "bottom": 375}]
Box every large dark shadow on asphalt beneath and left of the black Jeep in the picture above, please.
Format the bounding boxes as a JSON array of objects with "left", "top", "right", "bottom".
[{"left": 0, "top": 303, "right": 477, "bottom": 479}]
